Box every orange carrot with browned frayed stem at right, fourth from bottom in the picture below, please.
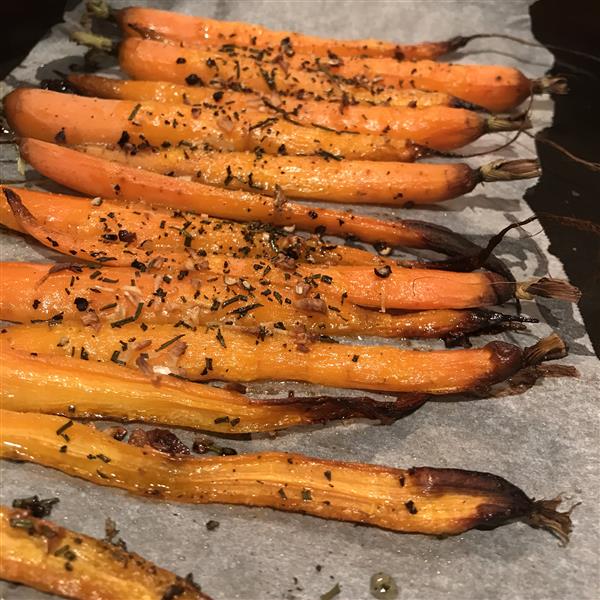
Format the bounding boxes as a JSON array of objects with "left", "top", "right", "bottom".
[{"left": 0, "top": 315, "right": 566, "bottom": 394}]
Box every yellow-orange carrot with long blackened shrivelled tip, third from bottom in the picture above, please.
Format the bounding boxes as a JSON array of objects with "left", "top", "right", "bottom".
[{"left": 0, "top": 348, "right": 426, "bottom": 435}]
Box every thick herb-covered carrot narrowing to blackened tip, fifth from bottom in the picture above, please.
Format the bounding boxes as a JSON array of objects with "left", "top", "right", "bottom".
[{"left": 0, "top": 262, "right": 536, "bottom": 338}]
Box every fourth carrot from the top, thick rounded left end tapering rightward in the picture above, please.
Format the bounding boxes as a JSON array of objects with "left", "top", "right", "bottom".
[{"left": 4, "top": 88, "right": 420, "bottom": 160}]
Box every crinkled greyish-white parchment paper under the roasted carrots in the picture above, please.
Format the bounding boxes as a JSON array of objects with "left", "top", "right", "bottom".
[{"left": 0, "top": 0, "right": 600, "bottom": 600}]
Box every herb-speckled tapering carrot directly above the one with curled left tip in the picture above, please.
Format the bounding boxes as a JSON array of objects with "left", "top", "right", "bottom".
[{"left": 0, "top": 186, "right": 385, "bottom": 266}]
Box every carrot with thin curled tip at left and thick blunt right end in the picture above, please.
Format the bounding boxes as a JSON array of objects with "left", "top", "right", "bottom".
[{"left": 4, "top": 195, "right": 515, "bottom": 311}]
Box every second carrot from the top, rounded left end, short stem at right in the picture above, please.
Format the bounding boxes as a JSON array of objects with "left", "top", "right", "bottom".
[{"left": 119, "top": 38, "right": 564, "bottom": 112}]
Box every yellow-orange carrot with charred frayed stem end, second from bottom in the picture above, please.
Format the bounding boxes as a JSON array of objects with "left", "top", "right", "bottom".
[{"left": 0, "top": 410, "right": 571, "bottom": 543}]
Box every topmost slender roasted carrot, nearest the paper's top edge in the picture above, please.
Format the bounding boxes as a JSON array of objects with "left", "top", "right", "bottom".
[{"left": 113, "top": 6, "right": 461, "bottom": 60}]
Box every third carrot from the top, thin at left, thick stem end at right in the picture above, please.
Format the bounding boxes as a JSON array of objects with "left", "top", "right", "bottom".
[{"left": 64, "top": 75, "right": 522, "bottom": 150}]
